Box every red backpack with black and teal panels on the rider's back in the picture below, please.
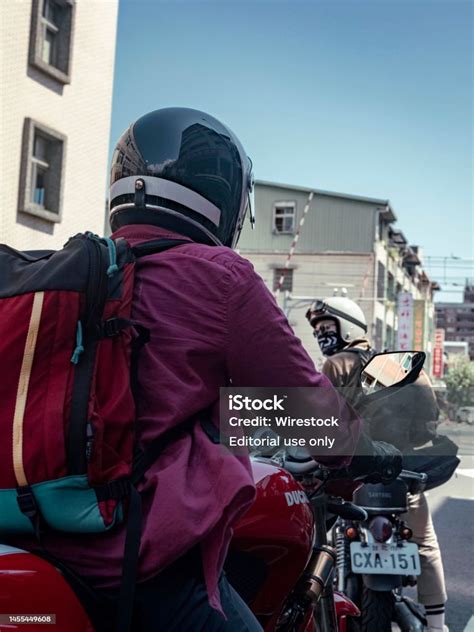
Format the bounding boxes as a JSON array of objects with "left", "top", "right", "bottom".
[{"left": 0, "top": 233, "right": 186, "bottom": 629}]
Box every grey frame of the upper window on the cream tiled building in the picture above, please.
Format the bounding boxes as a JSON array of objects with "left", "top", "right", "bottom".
[{"left": 29, "top": 0, "right": 76, "bottom": 84}]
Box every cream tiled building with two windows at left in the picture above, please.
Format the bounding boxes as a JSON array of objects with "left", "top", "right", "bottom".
[{"left": 0, "top": 0, "right": 118, "bottom": 249}]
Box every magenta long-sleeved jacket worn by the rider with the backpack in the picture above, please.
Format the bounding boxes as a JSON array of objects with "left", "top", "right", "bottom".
[{"left": 12, "top": 225, "right": 359, "bottom": 609}]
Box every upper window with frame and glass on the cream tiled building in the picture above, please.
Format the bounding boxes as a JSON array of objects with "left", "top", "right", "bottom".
[{"left": 30, "top": 0, "right": 75, "bottom": 83}]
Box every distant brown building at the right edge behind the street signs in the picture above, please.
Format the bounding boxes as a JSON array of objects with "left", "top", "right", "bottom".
[{"left": 435, "top": 281, "right": 474, "bottom": 360}]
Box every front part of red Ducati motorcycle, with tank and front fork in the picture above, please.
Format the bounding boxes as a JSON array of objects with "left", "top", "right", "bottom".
[{"left": 225, "top": 455, "right": 367, "bottom": 632}]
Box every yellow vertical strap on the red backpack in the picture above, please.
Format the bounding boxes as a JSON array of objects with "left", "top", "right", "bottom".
[{"left": 13, "top": 292, "right": 44, "bottom": 486}]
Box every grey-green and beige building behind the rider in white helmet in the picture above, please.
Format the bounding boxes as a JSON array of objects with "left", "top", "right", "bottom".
[{"left": 239, "top": 181, "right": 435, "bottom": 366}]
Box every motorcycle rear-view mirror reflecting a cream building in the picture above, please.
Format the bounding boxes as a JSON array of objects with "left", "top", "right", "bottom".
[{"left": 361, "top": 351, "right": 426, "bottom": 394}]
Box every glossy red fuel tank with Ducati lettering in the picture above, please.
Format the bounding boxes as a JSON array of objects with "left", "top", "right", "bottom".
[{"left": 228, "top": 460, "right": 314, "bottom": 615}]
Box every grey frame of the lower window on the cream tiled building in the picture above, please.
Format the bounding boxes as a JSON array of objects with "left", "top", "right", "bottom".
[{"left": 18, "top": 118, "right": 67, "bottom": 223}]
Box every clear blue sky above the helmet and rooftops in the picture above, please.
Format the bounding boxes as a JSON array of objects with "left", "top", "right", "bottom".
[{"left": 111, "top": 0, "right": 474, "bottom": 300}]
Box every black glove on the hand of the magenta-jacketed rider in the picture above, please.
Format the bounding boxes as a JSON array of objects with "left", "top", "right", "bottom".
[{"left": 348, "top": 432, "right": 402, "bottom": 484}]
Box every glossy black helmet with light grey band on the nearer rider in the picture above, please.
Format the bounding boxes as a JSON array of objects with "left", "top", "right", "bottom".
[{"left": 109, "top": 108, "right": 254, "bottom": 248}]
